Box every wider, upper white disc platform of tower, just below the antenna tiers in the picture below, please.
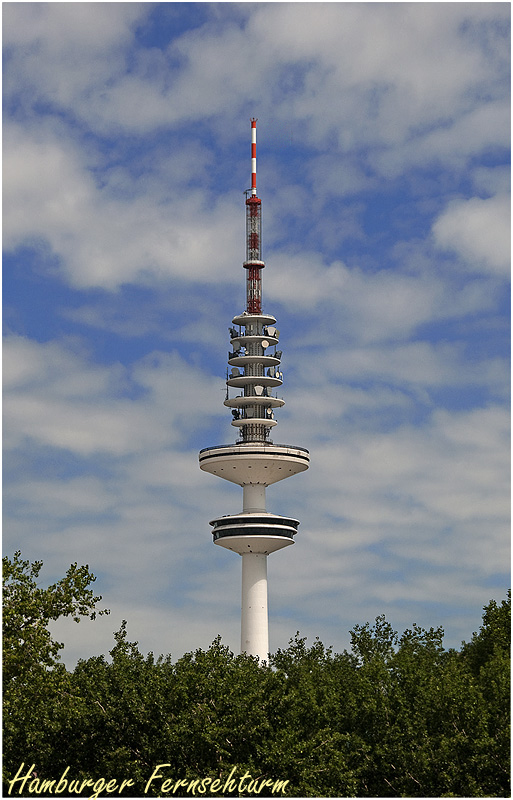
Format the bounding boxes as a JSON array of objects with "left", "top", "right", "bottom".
[{"left": 199, "top": 442, "right": 310, "bottom": 486}]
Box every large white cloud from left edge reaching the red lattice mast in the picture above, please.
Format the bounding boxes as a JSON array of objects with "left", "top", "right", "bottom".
[{"left": 3, "top": 120, "right": 243, "bottom": 289}]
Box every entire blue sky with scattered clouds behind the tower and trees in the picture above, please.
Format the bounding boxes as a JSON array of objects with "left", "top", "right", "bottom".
[{"left": 3, "top": 2, "right": 511, "bottom": 666}]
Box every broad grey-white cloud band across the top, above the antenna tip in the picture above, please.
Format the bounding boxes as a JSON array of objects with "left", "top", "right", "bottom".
[{"left": 4, "top": 3, "right": 509, "bottom": 166}]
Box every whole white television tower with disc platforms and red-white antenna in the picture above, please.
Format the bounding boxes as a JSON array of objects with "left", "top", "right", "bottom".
[{"left": 199, "top": 119, "right": 310, "bottom": 661}]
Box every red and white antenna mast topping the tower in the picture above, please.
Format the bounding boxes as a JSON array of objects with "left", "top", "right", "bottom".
[{"left": 244, "top": 117, "right": 265, "bottom": 314}]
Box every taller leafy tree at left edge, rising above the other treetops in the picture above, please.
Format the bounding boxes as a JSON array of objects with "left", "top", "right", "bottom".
[{"left": 3, "top": 550, "right": 108, "bottom": 776}]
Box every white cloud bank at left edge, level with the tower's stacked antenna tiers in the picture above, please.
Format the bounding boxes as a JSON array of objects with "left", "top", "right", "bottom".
[{"left": 4, "top": 336, "right": 224, "bottom": 456}]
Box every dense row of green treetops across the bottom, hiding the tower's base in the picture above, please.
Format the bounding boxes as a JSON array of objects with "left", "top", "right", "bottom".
[{"left": 5, "top": 556, "right": 510, "bottom": 797}]
